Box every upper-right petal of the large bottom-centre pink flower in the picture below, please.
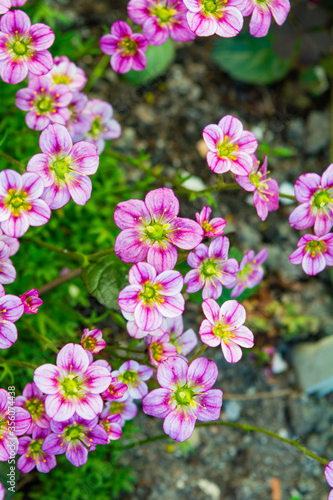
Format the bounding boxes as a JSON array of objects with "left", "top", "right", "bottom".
[{"left": 187, "top": 357, "right": 219, "bottom": 393}]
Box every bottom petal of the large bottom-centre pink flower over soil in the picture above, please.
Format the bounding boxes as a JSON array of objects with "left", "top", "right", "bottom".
[{"left": 163, "top": 407, "right": 196, "bottom": 443}]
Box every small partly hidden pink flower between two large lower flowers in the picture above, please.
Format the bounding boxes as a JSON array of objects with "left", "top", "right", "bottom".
[{"left": 111, "top": 360, "right": 154, "bottom": 399}]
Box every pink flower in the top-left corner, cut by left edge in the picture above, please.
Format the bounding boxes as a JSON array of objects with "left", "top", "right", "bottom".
[{"left": 0, "top": 10, "right": 54, "bottom": 83}]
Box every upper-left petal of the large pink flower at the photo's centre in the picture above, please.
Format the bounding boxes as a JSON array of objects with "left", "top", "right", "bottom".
[{"left": 114, "top": 200, "right": 151, "bottom": 229}]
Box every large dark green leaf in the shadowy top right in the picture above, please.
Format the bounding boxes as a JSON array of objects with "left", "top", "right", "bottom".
[{"left": 212, "top": 33, "right": 294, "bottom": 84}]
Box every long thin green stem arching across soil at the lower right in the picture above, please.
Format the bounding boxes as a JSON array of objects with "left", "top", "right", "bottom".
[{"left": 120, "top": 422, "right": 328, "bottom": 465}]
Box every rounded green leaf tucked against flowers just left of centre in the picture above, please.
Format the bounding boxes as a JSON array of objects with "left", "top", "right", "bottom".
[{"left": 82, "top": 251, "right": 130, "bottom": 309}]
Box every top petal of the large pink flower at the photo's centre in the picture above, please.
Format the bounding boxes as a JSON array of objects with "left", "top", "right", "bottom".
[{"left": 145, "top": 188, "right": 179, "bottom": 225}]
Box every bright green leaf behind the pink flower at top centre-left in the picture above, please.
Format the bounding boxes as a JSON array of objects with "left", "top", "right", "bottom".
[{"left": 124, "top": 38, "right": 175, "bottom": 85}]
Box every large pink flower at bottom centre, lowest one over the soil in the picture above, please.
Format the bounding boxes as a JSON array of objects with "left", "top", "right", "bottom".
[{"left": 142, "top": 356, "right": 222, "bottom": 442}]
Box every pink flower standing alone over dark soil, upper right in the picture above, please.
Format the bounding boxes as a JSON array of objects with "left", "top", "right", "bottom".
[{"left": 203, "top": 115, "right": 258, "bottom": 176}]
